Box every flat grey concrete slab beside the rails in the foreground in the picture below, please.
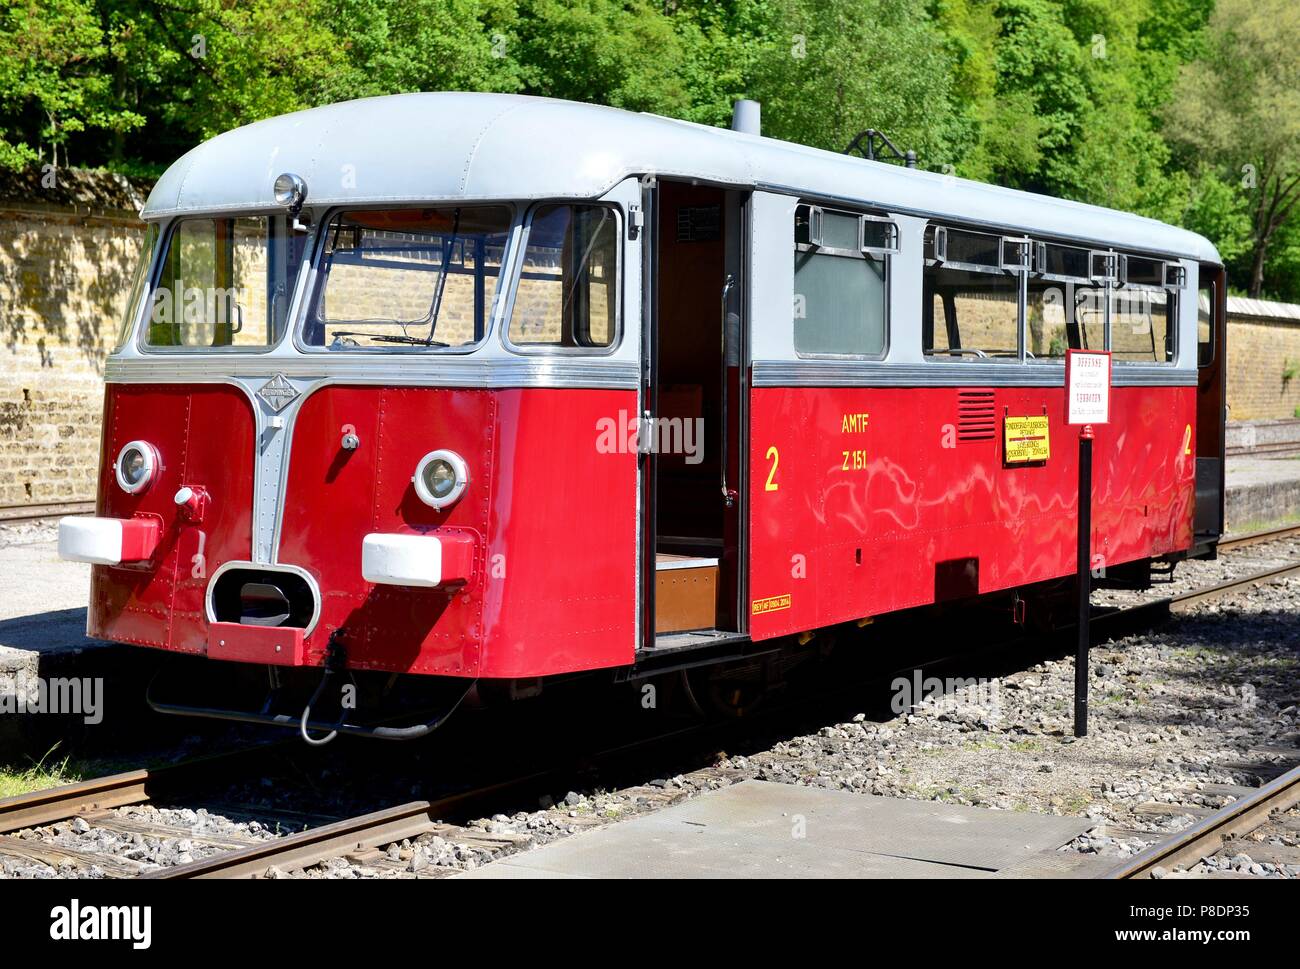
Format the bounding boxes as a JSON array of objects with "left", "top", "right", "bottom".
[{"left": 462, "top": 780, "right": 1095, "bottom": 879}]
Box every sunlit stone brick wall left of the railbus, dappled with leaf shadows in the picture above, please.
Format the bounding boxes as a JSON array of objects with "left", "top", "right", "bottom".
[{"left": 0, "top": 172, "right": 144, "bottom": 506}]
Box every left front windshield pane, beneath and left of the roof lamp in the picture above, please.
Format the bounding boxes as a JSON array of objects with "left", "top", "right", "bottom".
[{"left": 144, "top": 215, "right": 307, "bottom": 350}]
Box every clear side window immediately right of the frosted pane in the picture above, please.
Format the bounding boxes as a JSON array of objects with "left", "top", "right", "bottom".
[{"left": 922, "top": 225, "right": 1030, "bottom": 360}]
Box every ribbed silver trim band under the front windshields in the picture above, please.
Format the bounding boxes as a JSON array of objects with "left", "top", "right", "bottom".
[{"left": 104, "top": 356, "right": 641, "bottom": 390}]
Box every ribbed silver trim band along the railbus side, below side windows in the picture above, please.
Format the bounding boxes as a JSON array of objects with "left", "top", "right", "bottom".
[{"left": 753, "top": 360, "right": 1196, "bottom": 388}]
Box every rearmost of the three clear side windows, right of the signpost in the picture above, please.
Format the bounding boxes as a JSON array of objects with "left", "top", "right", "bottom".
[{"left": 1110, "top": 255, "right": 1182, "bottom": 363}]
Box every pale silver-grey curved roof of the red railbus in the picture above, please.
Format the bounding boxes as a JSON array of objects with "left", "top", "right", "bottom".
[{"left": 143, "top": 94, "right": 1219, "bottom": 263}]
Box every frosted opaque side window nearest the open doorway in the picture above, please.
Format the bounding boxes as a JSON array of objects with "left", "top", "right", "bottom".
[{"left": 794, "top": 206, "right": 898, "bottom": 356}]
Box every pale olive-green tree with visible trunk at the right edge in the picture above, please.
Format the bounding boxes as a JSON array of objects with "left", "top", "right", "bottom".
[{"left": 1166, "top": 0, "right": 1300, "bottom": 297}]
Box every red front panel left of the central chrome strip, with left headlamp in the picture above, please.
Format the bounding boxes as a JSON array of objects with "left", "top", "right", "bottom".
[{"left": 87, "top": 384, "right": 254, "bottom": 653}]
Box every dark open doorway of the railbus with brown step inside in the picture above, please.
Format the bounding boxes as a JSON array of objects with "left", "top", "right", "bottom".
[{"left": 641, "top": 182, "right": 748, "bottom": 646}]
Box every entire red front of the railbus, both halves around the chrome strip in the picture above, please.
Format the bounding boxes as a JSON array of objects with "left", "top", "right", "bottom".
[{"left": 90, "top": 385, "right": 637, "bottom": 678}]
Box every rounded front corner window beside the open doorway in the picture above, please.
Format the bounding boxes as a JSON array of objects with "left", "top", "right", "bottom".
[{"left": 510, "top": 206, "right": 620, "bottom": 350}]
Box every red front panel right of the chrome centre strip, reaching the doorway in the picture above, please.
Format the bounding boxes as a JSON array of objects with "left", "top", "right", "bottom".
[{"left": 278, "top": 386, "right": 636, "bottom": 678}]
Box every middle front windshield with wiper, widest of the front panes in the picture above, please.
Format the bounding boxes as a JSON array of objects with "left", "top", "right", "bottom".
[{"left": 304, "top": 206, "right": 511, "bottom": 350}]
